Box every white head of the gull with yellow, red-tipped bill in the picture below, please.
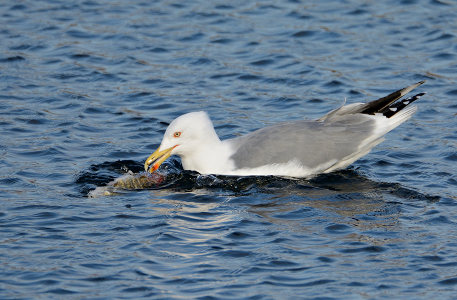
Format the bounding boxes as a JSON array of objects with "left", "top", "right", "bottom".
[{"left": 144, "top": 111, "right": 220, "bottom": 173}]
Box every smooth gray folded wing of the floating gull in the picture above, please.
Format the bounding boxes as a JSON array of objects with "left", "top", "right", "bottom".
[{"left": 229, "top": 114, "right": 375, "bottom": 168}]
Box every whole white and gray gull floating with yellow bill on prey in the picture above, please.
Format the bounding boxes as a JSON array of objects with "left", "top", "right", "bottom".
[{"left": 144, "top": 81, "right": 424, "bottom": 177}]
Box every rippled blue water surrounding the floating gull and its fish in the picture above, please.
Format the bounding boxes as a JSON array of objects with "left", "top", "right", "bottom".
[{"left": 0, "top": 0, "right": 457, "bottom": 299}]
